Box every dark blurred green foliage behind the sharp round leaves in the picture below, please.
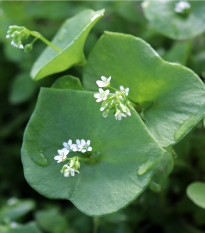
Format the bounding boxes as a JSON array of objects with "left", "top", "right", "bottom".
[{"left": 0, "top": 2, "right": 205, "bottom": 233}]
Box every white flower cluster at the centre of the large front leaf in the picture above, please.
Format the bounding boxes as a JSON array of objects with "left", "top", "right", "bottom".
[{"left": 54, "top": 139, "right": 92, "bottom": 177}]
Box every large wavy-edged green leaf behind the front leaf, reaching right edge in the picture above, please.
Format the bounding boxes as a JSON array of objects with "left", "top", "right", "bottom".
[{"left": 83, "top": 32, "right": 205, "bottom": 147}]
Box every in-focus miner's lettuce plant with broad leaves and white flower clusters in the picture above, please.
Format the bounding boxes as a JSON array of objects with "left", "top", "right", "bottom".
[{"left": 8, "top": 7, "right": 205, "bottom": 216}]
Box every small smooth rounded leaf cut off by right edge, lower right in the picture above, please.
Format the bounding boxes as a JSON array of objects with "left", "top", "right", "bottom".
[{"left": 187, "top": 182, "right": 205, "bottom": 209}]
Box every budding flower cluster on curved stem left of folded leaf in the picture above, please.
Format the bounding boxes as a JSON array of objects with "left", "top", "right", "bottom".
[{"left": 6, "top": 25, "right": 30, "bottom": 49}]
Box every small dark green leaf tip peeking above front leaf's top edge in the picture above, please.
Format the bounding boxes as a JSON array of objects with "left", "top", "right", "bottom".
[{"left": 52, "top": 75, "right": 82, "bottom": 90}]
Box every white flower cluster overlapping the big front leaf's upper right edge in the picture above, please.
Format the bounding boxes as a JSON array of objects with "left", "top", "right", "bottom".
[{"left": 94, "top": 76, "right": 133, "bottom": 120}]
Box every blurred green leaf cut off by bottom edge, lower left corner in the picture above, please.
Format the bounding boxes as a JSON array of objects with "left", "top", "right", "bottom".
[{"left": 6, "top": 222, "right": 42, "bottom": 233}]
